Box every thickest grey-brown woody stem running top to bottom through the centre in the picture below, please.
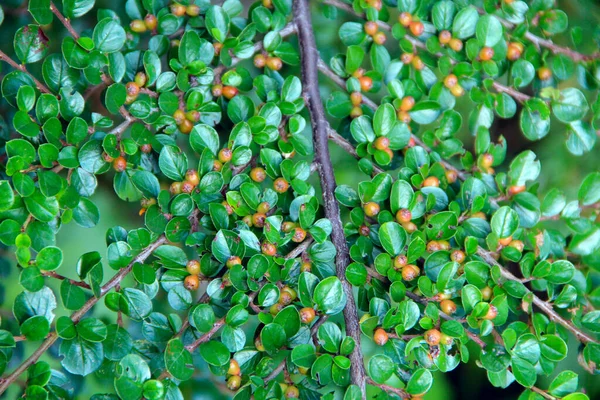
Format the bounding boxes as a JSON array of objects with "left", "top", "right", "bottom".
[{"left": 293, "top": 0, "right": 366, "bottom": 398}]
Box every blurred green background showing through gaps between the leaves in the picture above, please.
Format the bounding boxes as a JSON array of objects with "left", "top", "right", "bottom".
[{"left": 0, "top": 0, "right": 600, "bottom": 400}]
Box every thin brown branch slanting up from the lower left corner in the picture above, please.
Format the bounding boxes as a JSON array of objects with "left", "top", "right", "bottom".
[{"left": 0, "top": 236, "right": 167, "bottom": 395}]
